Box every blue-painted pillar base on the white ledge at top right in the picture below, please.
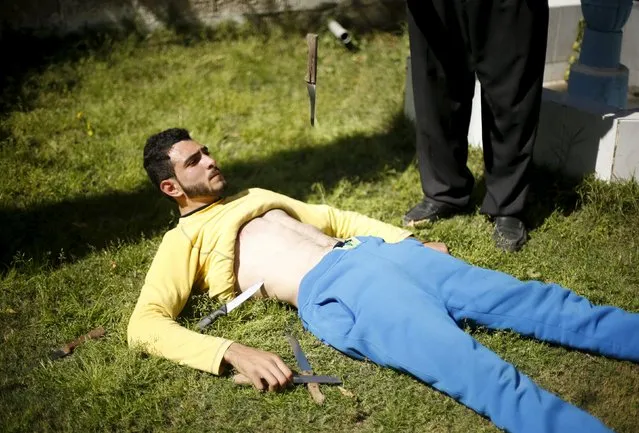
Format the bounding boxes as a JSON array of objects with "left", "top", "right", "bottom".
[{"left": 568, "top": 0, "right": 633, "bottom": 109}]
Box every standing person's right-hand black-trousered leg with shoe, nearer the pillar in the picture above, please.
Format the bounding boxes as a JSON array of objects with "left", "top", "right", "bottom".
[{"left": 464, "top": 0, "right": 548, "bottom": 251}]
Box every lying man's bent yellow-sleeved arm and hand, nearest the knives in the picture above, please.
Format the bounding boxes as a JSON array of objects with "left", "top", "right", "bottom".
[{"left": 128, "top": 233, "right": 292, "bottom": 390}]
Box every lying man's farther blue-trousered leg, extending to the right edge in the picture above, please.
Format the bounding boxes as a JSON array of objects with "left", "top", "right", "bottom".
[{"left": 383, "top": 240, "right": 639, "bottom": 362}]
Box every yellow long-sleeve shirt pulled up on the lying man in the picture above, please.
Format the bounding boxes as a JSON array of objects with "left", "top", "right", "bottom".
[{"left": 128, "top": 188, "right": 411, "bottom": 374}]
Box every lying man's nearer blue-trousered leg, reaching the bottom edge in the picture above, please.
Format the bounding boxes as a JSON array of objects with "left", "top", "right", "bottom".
[{"left": 299, "top": 236, "right": 609, "bottom": 433}]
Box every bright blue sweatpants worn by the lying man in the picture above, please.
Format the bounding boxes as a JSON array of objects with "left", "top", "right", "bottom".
[{"left": 298, "top": 237, "right": 639, "bottom": 433}]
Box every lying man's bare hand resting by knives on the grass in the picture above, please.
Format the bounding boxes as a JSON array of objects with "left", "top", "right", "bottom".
[{"left": 224, "top": 343, "right": 293, "bottom": 391}]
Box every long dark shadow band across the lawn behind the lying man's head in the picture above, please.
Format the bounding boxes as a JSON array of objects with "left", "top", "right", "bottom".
[{"left": 0, "top": 114, "right": 414, "bottom": 270}]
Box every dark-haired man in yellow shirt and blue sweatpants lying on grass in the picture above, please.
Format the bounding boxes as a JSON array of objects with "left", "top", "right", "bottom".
[{"left": 128, "top": 128, "right": 639, "bottom": 433}]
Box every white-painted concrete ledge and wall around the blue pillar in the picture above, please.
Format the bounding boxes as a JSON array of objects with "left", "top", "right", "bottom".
[{"left": 405, "top": 0, "right": 639, "bottom": 180}]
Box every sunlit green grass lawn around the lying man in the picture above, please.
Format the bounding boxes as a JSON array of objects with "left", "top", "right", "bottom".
[{"left": 0, "top": 22, "right": 639, "bottom": 433}]
